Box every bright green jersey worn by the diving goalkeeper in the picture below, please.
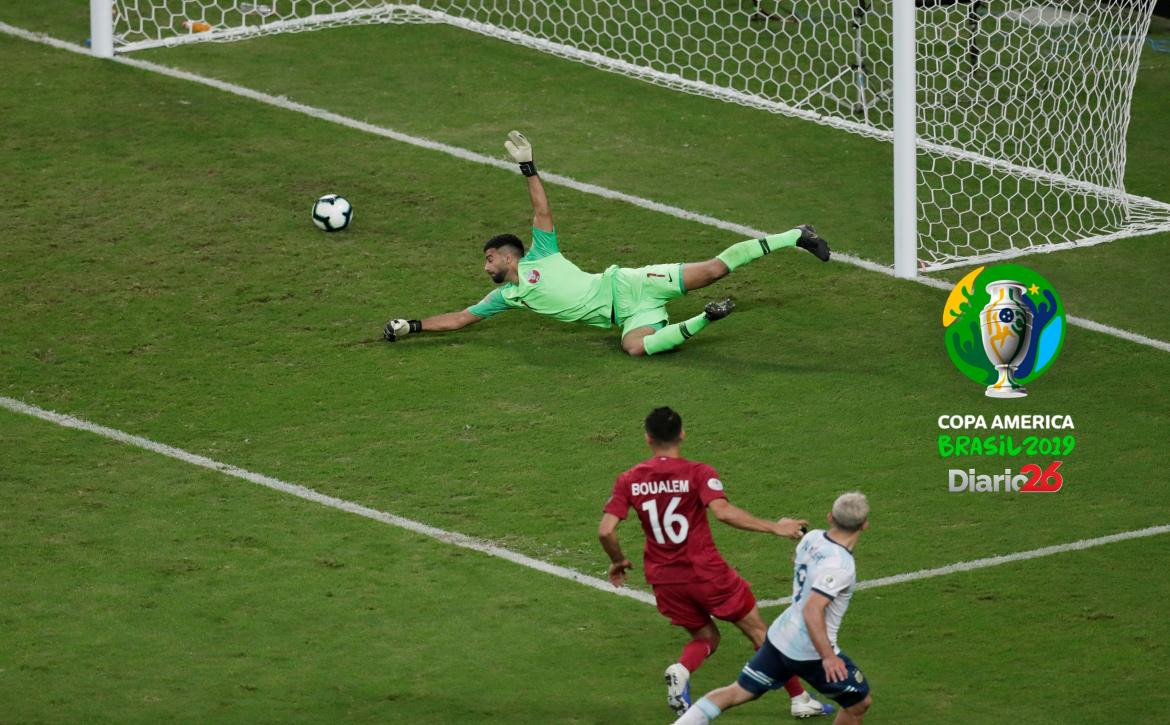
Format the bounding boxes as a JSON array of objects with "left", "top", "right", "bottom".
[{"left": 467, "top": 227, "right": 618, "bottom": 327}]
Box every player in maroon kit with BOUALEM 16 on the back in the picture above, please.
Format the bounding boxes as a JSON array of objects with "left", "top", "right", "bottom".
[{"left": 598, "top": 408, "right": 833, "bottom": 717}]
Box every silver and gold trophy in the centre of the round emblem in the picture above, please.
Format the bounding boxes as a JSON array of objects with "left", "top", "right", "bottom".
[{"left": 979, "top": 279, "right": 1032, "bottom": 398}]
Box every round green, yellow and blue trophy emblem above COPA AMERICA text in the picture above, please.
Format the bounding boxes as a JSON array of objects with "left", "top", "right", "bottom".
[{"left": 943, "top": 264, "right": 1065, "bottom": 398}]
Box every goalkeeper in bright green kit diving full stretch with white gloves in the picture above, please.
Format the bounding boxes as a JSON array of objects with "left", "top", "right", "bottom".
[{"left": 384, "top": 131, "right": 830, "bottom": 355}]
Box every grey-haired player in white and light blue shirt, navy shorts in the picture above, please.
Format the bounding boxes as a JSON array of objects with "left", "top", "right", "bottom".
[{"left": 675, "top": 491, "right": 873, "bottom": 725}]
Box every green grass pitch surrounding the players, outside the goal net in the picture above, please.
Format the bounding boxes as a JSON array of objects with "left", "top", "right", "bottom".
[{"left": 0, "top": 0, "right": 1170, "bottom": 723}]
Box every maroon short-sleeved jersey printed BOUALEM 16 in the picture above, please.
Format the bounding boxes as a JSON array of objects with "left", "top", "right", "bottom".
[{"left": 605, "top": 456, "right": 735, "bottom": 585}]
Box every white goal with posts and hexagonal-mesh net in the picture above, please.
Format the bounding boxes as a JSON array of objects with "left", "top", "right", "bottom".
[{"left": 90, "top": 0, "right": 1170, "bottom": 277}]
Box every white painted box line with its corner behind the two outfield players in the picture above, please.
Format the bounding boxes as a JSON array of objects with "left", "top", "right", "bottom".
[{"left": 0, "top": 396, "right": 1170, "bottom": 607}]
